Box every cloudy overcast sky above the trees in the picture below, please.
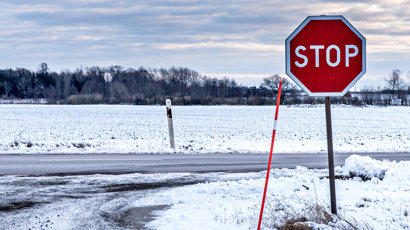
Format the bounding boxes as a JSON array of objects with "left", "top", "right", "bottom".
[{"left": 0, "top": 0, "right": 410, "bottom": 87}]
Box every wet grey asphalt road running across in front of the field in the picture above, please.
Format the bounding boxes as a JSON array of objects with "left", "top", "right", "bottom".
[{"left": 0, "top": 152, "right": 410, "bottom": 175}]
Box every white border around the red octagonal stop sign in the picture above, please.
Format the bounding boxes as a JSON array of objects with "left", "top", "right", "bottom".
[{"left": 285, "top": 15, "right": 366, "bottom": 97}]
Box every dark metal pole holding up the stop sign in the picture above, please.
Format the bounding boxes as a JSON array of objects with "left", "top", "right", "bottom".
[{"left": 325, "top": 97, "right": 337, "bottom": 215}]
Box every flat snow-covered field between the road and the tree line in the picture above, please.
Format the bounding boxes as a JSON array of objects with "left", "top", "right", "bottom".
[{"left": 0, "top": 105, "right": 410, "bottom": 153}]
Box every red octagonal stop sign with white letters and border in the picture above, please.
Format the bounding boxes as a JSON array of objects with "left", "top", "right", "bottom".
[{"left": 286, "top": 16, "right": 366, "bottom": 96}]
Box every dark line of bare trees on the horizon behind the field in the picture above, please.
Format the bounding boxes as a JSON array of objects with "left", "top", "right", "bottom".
[{"left": 0, "top": 63, "right": 408, "bottom": 105}]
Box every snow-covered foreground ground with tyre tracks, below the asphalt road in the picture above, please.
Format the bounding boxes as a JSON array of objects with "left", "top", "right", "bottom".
[{"left": 0, "top": 155, "right": 410, "bottom": 230}]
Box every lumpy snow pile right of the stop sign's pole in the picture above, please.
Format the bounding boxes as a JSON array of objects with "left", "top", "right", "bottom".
[{"left": 343, "top": 155, "right": 396, "bottom": 180}]
